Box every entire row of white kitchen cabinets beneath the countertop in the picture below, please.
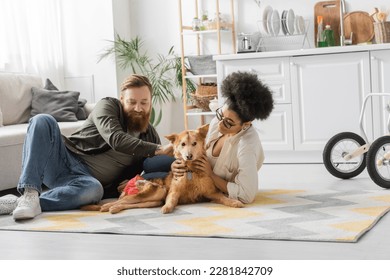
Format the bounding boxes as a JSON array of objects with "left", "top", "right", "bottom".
[{"left": 215, "top": 44, "right": 390, "bottom": 163}]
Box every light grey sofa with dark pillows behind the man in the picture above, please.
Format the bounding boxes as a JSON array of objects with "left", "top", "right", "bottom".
[{"left": 0, "top": 72, "right": 93, "bottom": 191}]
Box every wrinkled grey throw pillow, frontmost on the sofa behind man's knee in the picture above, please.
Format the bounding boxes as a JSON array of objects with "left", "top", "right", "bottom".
[{"left": 31, "top": 87, "right": 80, "bottom": 122}]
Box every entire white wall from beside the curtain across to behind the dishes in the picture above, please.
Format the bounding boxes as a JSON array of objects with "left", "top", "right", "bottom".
[{"left": 62, "top": 0, "right": 390, "bottom": 135}]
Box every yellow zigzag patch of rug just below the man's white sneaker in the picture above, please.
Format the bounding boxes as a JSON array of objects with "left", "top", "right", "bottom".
[{"left": 33, "top": 212, "right": 107, "bottom": 231}]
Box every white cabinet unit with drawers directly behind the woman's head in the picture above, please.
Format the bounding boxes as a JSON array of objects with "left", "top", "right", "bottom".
[{"left": 217, "top": 58, "right": 294, "bottom": 151}]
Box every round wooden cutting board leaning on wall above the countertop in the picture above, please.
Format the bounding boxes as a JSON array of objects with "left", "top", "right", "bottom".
[{"left": 344, "top": 11, "right": 375, "bottom": 45}]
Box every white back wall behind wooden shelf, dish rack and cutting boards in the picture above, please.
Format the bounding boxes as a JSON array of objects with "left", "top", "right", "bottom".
[{"left": 123, "top": 0, "right": 390, "bottom": 135}]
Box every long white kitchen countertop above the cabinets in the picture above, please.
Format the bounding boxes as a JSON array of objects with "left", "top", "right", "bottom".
[{"left": 213, "top": 44, "right": 390, "bottom": 61}]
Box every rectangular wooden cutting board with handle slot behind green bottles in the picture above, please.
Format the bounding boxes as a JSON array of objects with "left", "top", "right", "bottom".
[{"left": 314, "top": 0, "right": 338, "bottom": 46}]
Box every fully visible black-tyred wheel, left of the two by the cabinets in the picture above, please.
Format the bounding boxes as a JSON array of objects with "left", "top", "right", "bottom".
[{"left": 322, "top": 132, "right": 366, "bottom": 179}]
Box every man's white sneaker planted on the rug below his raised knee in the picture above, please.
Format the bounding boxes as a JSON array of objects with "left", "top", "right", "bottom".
[{"left": 12, "top": 188, "right": 42, "bottom": 221}]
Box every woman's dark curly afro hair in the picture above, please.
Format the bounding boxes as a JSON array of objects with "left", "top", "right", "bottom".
[{"left": 221, "top": 72, "right": 274, "bottom": 122}]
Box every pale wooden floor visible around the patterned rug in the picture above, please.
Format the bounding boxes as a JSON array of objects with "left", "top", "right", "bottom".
[{"left": 0, "top": 164, "right": 390, "bottom": 260}]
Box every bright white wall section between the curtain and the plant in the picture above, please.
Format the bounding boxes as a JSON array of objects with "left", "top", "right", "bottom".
[{"left": 61, "top": 0, "right": 117, "bottom": 102}]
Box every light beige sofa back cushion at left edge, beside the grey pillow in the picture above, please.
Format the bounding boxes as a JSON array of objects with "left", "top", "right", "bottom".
[{"left": 0, "top": 72, "right": 42, "bottom": 125}]
